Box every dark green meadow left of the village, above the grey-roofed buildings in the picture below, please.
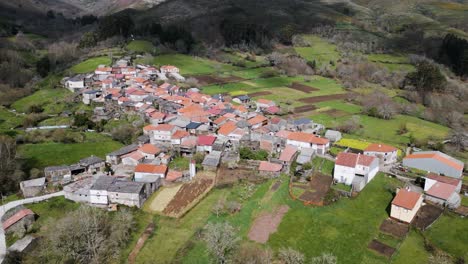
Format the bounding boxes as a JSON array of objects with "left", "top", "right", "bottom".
[{"left": 18, "top": 133, "right": 122, "bottom": 168}]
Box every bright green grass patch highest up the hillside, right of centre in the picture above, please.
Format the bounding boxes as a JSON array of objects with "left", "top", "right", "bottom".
[{"left": 294, "top": 35, "right": 340, "bottom": 67}]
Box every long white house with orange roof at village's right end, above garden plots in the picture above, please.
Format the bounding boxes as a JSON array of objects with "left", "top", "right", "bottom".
[{"left": 286, "top": 132, "right": 330, "bottom": 154}]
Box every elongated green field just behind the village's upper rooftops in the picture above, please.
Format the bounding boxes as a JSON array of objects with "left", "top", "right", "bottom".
[{"left": 149, "top": 54, "right": 238, "bottom": 75}]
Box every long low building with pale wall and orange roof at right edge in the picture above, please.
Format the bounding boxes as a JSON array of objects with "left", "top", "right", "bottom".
[{"left": 403, "top": 151, "right": 465, "bottom": 179}]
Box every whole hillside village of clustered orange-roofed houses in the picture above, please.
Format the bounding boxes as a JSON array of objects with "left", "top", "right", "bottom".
[{"left": 2, "top": 58, "right": 468, "bottom": 262}]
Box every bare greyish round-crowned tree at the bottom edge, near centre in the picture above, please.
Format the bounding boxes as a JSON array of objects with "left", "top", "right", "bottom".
[{"left": 203, "top": 222, "right": 239, "bottom": 264}]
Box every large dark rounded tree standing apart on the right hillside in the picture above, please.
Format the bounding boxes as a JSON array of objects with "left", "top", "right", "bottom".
[{"left": 405, "top": 60, "right": 447, "bottom": 92}]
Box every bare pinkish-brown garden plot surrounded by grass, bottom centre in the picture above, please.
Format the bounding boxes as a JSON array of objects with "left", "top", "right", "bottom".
[{"left": 248, "top": 205, "right": 289, "bottom": 244}]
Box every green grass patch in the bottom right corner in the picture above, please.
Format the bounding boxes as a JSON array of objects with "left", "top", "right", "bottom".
[{"left": 426, "top": 213, "right": 468, "bottom": 258}]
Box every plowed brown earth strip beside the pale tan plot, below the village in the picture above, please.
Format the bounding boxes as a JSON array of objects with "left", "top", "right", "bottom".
[{"left": 163, "top": 179, "right": 213, "bottom": 215}]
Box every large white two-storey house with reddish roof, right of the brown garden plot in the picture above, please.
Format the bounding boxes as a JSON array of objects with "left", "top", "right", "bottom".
[{"left": 333, "top": 152, "right": 379, "bottom": 192}]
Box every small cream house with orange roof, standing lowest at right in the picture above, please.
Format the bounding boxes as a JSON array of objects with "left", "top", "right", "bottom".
[{"left": 390, "top": 189, "right": 423, "bottom": 223}]
